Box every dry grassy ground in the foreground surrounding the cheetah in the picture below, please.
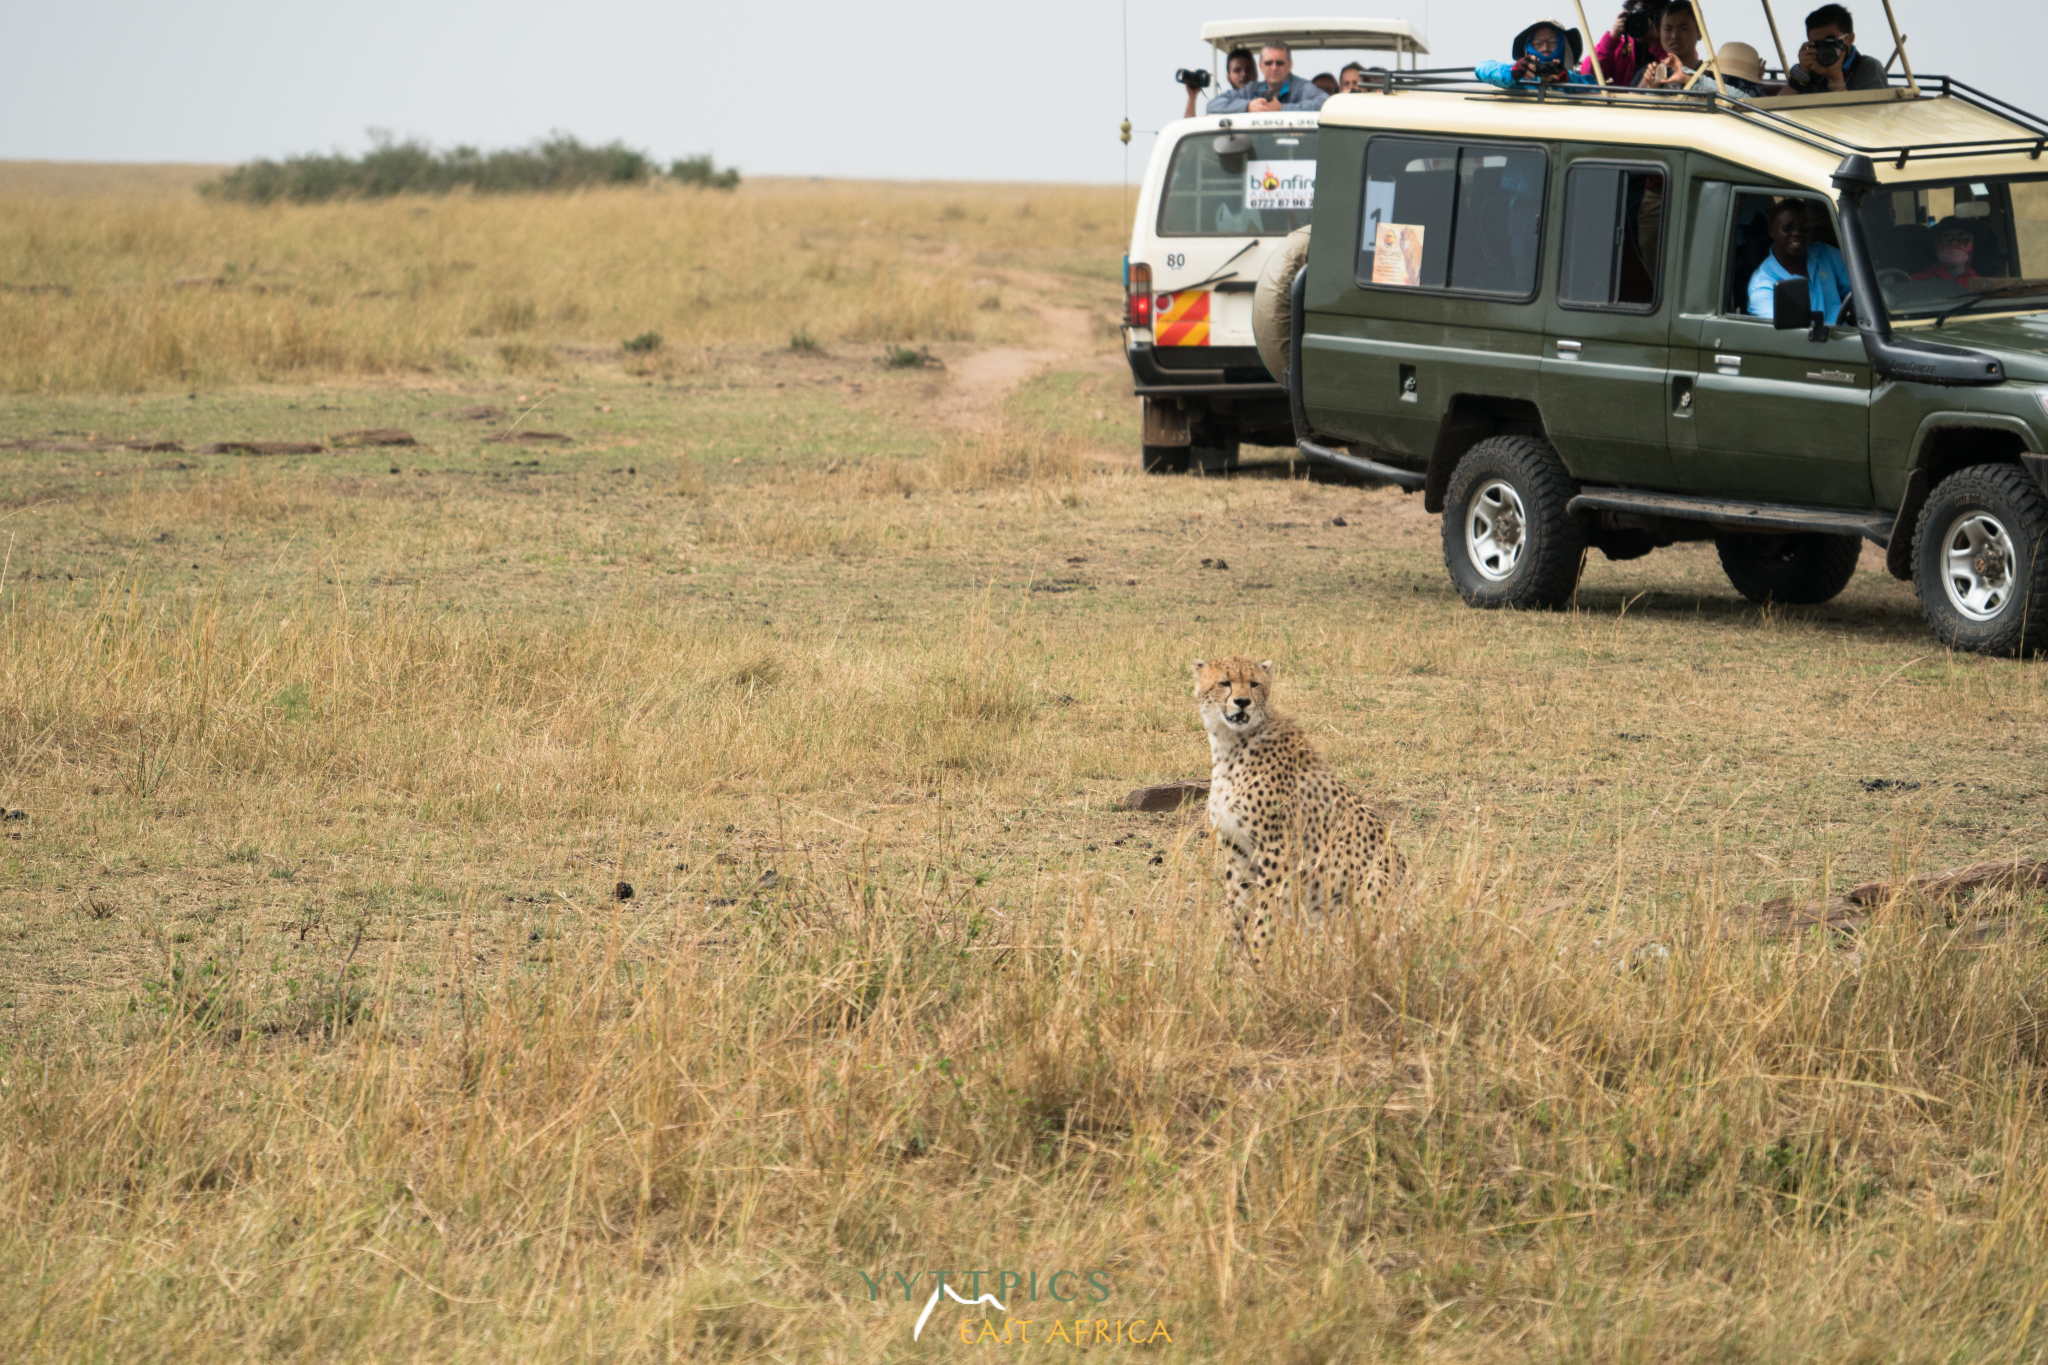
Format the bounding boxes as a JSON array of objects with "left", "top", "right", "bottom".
[{"left": 0, "top": 165, "right": 2048, "bottom": 1363}]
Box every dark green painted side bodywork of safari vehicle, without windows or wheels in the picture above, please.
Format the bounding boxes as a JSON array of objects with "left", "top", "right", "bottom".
[{"left": 1298, "top": 127, "right": 2048, "bottom": 527}]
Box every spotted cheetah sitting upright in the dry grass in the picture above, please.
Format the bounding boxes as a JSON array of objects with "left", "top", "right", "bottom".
[{"left": 1194, "top": 657, "right": 1405, "bottom": 966}]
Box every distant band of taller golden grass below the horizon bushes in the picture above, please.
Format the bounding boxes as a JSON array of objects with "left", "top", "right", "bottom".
[{"left": 0, "top": 168, "right": 1122, "bottom": 393}]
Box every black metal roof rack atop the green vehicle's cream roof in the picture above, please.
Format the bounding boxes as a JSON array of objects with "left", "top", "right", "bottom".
[{"left": 1335, "top": 68, "right": 2048, "bottom": 170}]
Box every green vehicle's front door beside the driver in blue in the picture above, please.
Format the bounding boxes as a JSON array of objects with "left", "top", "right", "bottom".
[{"left": 1673, "top": 182, "right": 1872, "bottom": 508}]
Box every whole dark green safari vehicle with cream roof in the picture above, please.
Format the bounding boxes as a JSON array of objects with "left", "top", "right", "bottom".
[{"left": 1260, "top": 34, "right": 2048, "bottom": 655}]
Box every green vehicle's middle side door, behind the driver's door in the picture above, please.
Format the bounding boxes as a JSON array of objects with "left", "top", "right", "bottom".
[{"left": 1538, "top": 147, "right": 1681, "bottom": 489}]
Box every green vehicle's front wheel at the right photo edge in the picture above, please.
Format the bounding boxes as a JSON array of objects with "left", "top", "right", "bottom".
[{"left": 1913, "top": 465, "right": 2048, "bottom": 659}]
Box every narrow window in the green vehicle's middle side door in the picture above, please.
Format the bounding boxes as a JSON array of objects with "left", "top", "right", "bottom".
[{"left": 1556, "top": 162, "right": 1667, "bottom": 313}]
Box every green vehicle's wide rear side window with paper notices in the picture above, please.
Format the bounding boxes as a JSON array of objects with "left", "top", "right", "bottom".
[{"left": 1358, "top": 137, "right": 1550, "bottom": 299}]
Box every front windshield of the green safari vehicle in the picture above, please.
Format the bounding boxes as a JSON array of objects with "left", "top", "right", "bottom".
[{"left": 1864, "top": 176, "right": 2048, "bottom": 317}]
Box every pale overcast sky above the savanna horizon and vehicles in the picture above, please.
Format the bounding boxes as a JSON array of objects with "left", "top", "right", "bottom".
[{"left": 0, "top": 0, "right": 2048, "bottom": 182}]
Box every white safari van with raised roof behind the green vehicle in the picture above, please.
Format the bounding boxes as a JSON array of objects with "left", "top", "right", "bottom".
[{"left": 1124, "top": 18, "right": 1430, "bottom": 473}]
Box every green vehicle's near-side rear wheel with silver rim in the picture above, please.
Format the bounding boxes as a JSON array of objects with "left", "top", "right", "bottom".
[{"left": 1444, "top": 436, "right": 1587, "bottom": 610}]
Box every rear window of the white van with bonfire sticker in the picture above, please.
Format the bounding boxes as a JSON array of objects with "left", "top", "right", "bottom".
[{"left": 1159, "top": 129, "right": 1315, "bottom": 237}]
